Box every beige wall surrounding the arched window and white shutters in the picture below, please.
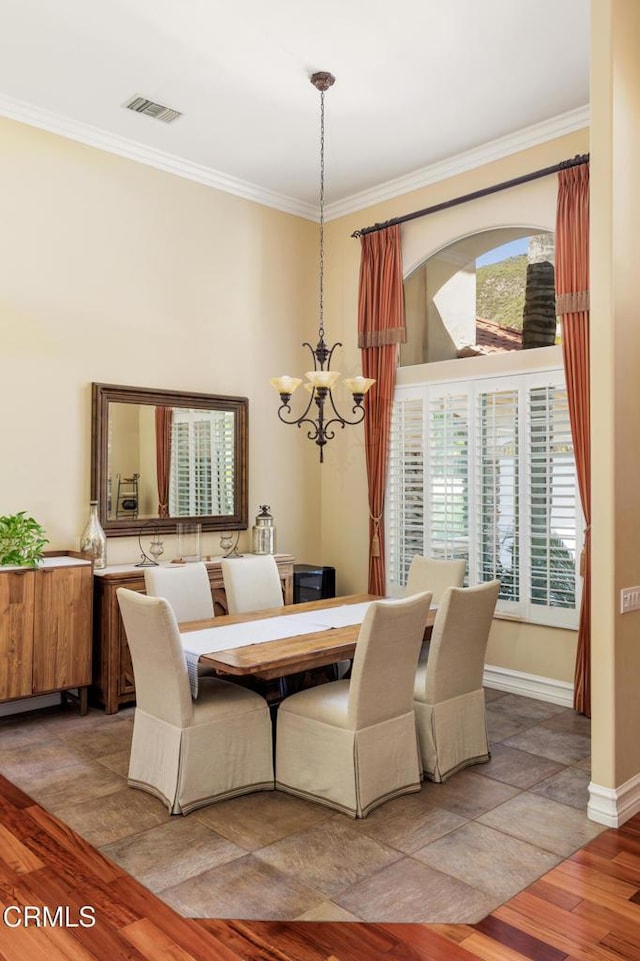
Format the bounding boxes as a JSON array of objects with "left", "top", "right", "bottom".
[{"left": 322, "top": 131, "right": 589, "bottom": 682}]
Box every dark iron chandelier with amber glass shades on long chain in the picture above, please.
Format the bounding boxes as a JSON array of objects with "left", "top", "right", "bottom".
[{"left": 271, "top": 71, "right": 375, "bottom": 463}]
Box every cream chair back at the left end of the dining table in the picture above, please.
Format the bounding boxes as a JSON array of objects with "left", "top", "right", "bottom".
[{"left": 116, "top": 587, "right": 193, "bottom": 727}]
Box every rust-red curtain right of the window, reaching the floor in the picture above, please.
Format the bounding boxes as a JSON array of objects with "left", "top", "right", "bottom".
[{"left": 556, "top": 163, "right": 591, "bottom": 717}]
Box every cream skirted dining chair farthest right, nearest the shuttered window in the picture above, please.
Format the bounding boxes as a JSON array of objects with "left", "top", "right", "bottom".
[{"left": 413, "top": 581, "right": 500, "bottom": 781}]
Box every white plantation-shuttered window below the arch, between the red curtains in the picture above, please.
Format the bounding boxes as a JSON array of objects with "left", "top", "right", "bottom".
[{"left": 385, "top": 369, "right": 582, "bottom": 627}]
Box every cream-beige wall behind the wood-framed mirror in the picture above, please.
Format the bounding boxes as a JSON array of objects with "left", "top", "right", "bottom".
[{"left": 0, "top": 119, "right": 320, "bottom": 563}]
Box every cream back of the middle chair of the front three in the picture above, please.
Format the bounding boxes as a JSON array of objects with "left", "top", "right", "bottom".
[{"left": 348, "top": 591, "right": 431, "bottom": 730}]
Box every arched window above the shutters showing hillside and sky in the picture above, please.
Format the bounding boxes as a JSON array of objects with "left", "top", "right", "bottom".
[{"left": 399, "top": 227, "right": 558, "bottom": 367}]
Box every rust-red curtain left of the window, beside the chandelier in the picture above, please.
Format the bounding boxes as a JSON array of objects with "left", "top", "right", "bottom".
[{"left": 358, "top": 225, "right": 406, "bottom": 596}]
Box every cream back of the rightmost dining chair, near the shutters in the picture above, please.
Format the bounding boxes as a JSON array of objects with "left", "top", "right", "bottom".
[{"left": 416, "top": 581, "right": 500, "bottom": 704}]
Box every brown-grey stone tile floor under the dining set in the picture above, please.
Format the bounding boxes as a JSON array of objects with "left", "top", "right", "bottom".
[{"left": 0, "top": 690, "right": 604, "bottom": 923}]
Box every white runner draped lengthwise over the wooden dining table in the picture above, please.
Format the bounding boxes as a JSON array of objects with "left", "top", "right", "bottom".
[{"left": 180, "top": 601, "right": 373, "bottom": 698}]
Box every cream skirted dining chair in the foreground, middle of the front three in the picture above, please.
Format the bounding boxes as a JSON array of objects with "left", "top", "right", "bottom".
[{"left": 276, "top": 593, "right": 431, "bottom": 818}]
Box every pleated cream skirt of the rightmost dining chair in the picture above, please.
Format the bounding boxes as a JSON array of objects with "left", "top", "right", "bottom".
[{"left": 413, "top": 690, "right": 490, "bottom": 781}]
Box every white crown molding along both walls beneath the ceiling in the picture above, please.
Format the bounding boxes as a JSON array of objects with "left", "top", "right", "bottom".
[{"left": 0, "top": 95, "right": 589, "bottom": 222}]
